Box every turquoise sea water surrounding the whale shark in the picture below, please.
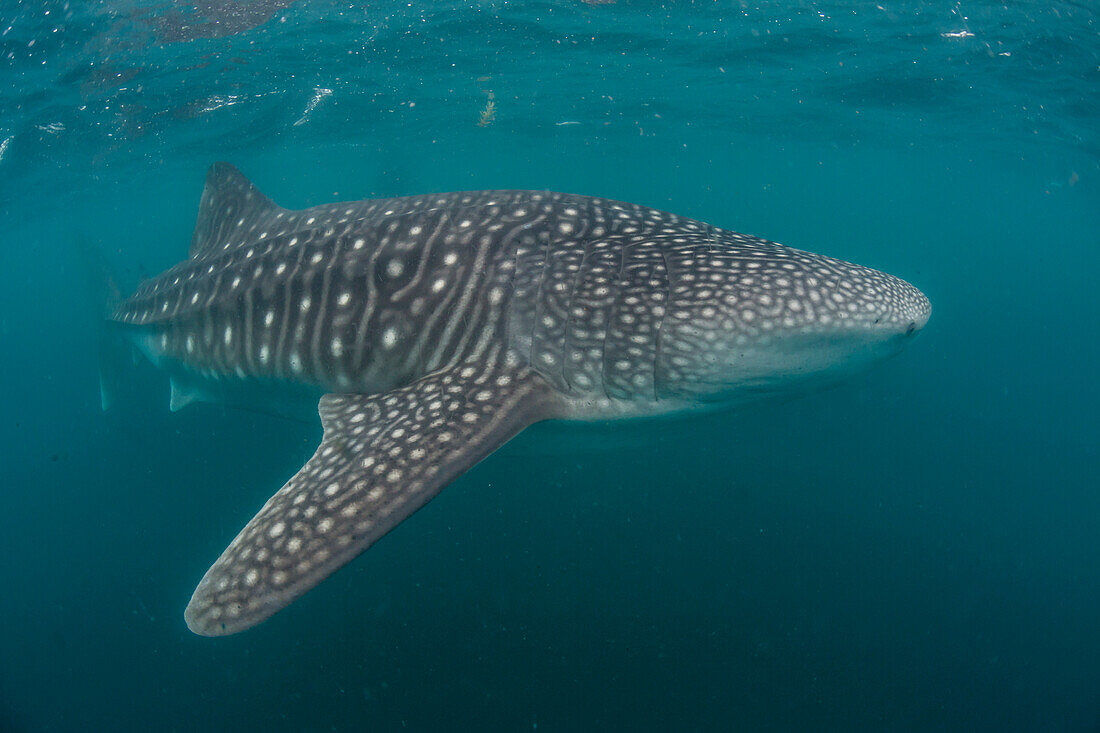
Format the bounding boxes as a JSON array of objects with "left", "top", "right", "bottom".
[{"left": 0, "top": 0, "right": 1100, "bottom": 731}]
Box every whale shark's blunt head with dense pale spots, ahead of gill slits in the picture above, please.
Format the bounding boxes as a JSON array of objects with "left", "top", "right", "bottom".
[{"left": 669, "top": 240, "right": 931, "bottom": 402}]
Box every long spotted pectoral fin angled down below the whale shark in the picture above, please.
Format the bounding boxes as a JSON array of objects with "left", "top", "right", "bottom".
[{"left": 185, "top": 349, "right": 553, "bottom": 636}]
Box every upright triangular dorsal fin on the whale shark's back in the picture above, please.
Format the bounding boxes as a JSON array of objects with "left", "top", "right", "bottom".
[{"left": 188, "top": 163, "right": 285, "bottom": 258}]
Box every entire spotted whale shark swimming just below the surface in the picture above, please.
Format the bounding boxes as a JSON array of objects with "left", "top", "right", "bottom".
[{"left": 108, "top": 163, "right": 931, "bottom": 636}]
